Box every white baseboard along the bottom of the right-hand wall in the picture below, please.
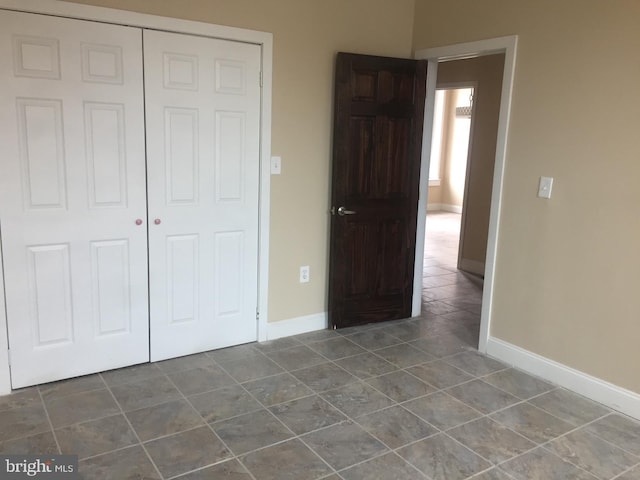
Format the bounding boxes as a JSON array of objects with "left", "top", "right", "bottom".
[{"left": 487, "top": 337, "right": 640, "bottom": 420}]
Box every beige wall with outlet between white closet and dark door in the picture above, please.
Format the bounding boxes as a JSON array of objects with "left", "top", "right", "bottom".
[{"left": 66, "top": 0, "right": 414, "bottom": 322}]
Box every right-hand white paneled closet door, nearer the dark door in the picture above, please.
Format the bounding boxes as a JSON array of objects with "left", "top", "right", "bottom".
[{"left": 144, "top": 31, "right": 260, "bottom": 360}]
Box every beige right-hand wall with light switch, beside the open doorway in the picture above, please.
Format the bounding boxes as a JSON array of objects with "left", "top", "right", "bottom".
[{"left": 414, "top": 0, "right": 640, "bottom": 392}]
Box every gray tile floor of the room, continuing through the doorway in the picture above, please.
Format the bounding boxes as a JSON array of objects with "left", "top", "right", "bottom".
[{"left": 0, "top": 214, "right": 640, "bottom": 480}]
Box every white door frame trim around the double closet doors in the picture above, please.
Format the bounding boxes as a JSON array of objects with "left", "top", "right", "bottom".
[{"left": 0, "top": 0, "right": 273, "bottom": 395}]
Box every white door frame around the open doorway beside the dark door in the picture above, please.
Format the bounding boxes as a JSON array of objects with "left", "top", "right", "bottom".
[{"left": 412, "top": 35, "right": 518, "bottom": 353}]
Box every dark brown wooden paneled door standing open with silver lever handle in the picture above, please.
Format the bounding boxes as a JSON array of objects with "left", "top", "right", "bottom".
[{"left": 329, "top": 53, "right": 427, "bottom": 328}]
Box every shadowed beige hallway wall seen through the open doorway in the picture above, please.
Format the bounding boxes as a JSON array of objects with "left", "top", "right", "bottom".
[{"left": 437, "top": 54, "right": 504, "bottom": 264}]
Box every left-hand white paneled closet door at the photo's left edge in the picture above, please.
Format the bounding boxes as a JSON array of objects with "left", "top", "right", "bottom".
[{"left": 0, "top": 11, "right": 149, "bottom": 388}]
